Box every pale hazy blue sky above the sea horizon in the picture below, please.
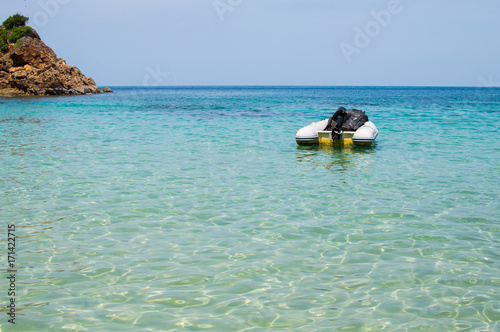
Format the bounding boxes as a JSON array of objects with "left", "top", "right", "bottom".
[{"left": 0, "top": 0, "right": 500, "bottom": 86}]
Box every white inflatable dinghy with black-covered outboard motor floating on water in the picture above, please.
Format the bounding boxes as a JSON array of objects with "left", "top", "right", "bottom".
[{"left": 295, "top": 107, "right": 378, "bottom": 146}]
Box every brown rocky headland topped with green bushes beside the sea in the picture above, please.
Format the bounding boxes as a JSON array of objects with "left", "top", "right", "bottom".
[{"left": 0, "top": 14, "right": 113, "bottom": 96}]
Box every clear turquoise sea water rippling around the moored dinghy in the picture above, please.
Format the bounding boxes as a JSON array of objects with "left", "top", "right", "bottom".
[{"left": 0, "top": 87, "right": 500, "bottom": 331}]
